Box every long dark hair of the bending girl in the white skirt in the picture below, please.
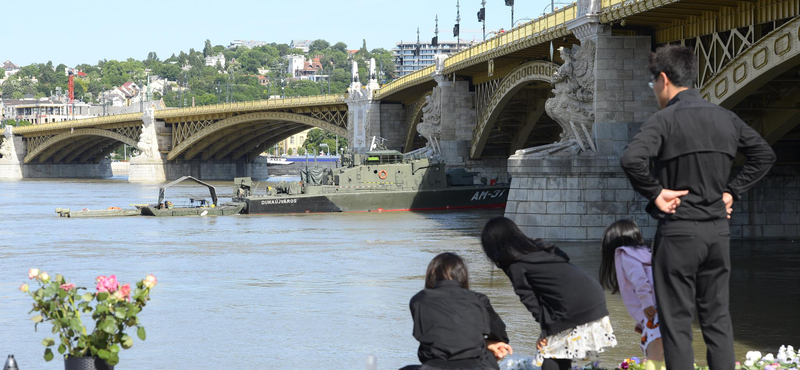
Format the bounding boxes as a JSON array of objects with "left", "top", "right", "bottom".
[{"left": 481, "top": 217, "right": 553, "bottom": 268}]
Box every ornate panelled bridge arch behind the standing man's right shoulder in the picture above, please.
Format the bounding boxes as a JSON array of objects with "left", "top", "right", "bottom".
[{"left": 700, "top": 17, "right": 800, "bottom": 145}]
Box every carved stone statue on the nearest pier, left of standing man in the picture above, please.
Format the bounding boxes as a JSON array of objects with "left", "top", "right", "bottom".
[{"left": 545, "top": 40, "right": 596, "bottom": 151}]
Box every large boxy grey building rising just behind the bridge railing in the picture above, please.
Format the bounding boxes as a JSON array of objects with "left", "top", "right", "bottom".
[{"left": 392, "top": 40, "right": 472, "bottom": 76}]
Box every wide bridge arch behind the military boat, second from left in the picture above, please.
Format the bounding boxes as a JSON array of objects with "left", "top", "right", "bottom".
[{"left": 167, "top": 112, "right": 347, "bottom": 160}]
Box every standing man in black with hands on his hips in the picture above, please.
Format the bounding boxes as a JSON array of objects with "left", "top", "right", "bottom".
[{"left": 621, "top": 45, "right": 775, "bottom": 370}]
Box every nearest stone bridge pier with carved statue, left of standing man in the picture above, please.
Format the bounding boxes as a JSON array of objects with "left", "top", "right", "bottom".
[{"left": 506, "top": 7, "right": 657, "bottom": 241}]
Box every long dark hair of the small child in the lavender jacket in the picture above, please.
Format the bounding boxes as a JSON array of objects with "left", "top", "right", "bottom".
[{"left": 600, "top": 220, "right": 644, "bottom": 294}]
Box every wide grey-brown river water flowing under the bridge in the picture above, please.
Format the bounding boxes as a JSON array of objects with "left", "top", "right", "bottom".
[{"left": 0, "top": 179, "right": 800, "bottom": 370}]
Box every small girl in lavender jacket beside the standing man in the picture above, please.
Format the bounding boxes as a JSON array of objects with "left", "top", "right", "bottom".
[{"left": 600, "top": 220, "right": 664, "bottom": 370}]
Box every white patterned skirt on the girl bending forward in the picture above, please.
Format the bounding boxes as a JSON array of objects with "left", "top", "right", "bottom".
[{"left": 534, "top": 316, "right": 617, "bottom": 366}]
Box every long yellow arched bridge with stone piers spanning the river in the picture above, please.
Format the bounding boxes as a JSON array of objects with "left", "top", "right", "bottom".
[{"left": 0, "top": 0, "right": 800, "bottom": 240}]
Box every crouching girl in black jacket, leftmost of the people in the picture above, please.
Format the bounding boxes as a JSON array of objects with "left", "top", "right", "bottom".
[{"left": 410, "top": 253, "right": 512, "bottom": 370}]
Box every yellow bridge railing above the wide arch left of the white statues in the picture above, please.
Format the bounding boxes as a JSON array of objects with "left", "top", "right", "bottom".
[{"left": 155, "top": 94, "right": 345, "bottom": 118}]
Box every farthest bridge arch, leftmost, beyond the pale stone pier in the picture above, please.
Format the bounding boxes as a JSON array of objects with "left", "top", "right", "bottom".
[{"left": 24, "top": 128, "right": 138, "bottom": 163}]
